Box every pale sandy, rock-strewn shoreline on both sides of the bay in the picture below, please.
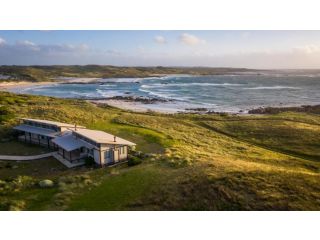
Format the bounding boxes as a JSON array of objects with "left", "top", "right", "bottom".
[{"left": 0, "top": 78, "right": 320, "bottom": 115}]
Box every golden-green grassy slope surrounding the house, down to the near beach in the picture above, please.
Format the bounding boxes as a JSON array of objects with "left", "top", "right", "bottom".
[{"left": 0, "top": 92, "right": 320, "bottom": 210}]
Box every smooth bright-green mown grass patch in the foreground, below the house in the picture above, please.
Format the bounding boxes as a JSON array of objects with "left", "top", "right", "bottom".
[{"left": 68, "top": 165, "right": 170, "bottom": 211}]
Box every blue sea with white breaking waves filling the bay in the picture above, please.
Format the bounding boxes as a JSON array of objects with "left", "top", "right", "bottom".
[{"left": 15, "top": 74, "right": 320, "bottom": 112}]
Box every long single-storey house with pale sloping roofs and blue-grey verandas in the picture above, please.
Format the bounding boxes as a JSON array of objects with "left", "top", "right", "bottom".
[{"left": 14, "top": 118, "right": 136, "bottom": 165}]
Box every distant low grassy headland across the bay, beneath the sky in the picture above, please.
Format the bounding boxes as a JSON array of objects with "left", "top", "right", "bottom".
[{"left": 0, "top": 65, "right": 252, "bottom": 82}]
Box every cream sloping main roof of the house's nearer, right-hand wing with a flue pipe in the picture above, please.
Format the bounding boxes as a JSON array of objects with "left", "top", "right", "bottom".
[{"left": 72, "top": 128, "right": 136, "bottom": 146}]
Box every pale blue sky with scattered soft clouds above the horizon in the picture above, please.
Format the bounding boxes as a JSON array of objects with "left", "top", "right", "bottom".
[{"left": 0, "top": 30, "right": 320, "bottom": 69}]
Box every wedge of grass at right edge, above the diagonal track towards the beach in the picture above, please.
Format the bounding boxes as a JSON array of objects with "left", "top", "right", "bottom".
[{"left": 199, "top": 119, "right": 320, "bottom": 161}]
